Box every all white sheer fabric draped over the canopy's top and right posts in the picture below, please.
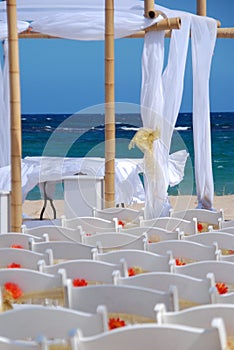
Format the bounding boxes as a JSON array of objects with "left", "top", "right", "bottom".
[{"left": 0, "top": 0, "right": 217, "bottom": 219}]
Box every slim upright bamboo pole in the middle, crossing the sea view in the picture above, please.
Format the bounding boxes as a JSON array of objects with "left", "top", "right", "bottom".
[{"left": 105, "top": 0, "right": 115, "bottom": 208}]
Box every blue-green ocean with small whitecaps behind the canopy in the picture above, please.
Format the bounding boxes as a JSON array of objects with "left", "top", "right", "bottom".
[{"left": 22, "top": 112, "right": 234, "bottom": 199}]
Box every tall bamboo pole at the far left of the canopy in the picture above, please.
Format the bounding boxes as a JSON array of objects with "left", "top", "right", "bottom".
[{"left": 7, "top": 0, "right": 22, "bottom": 232}]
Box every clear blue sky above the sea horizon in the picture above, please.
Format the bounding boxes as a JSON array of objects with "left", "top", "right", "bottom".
[{"left": 16, "top": 0, "right": 234, "bottom": 114}]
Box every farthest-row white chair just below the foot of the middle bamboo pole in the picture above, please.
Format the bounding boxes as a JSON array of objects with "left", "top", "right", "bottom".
[{"left": 93, "top": 207, "right": 144, "bottom": 226}]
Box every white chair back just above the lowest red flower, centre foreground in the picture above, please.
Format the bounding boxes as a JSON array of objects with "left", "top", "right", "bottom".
[{"left": 66, "top": 279, "right": 178, "bottom": 316}]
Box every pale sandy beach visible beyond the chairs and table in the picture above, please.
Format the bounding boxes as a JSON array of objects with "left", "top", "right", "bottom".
[{"left": 23, "top": 195, "right": 234, "bottom": 220}]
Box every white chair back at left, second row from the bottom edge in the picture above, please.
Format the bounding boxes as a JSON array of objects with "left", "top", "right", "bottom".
[{"left": 0, "top": 305, "right": 108, "bottom": 340}]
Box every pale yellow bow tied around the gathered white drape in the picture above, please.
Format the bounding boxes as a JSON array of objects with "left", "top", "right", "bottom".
[{"left": 128, "top": 128, "right": 160, "bottom": 153}]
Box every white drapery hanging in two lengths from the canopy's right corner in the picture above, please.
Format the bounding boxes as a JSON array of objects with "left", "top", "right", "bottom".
[{"left": 141, "top": 7, "right": 217, "bottom": 219}]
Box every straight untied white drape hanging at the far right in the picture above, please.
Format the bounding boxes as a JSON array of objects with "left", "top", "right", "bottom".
[{"left": 191, "top": 16, "right": 217, "bottom": 209}]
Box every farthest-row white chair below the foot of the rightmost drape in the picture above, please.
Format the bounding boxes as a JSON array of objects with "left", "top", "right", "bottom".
[{"left": 170, "top": 209, "right": 224, "bottom": 228}]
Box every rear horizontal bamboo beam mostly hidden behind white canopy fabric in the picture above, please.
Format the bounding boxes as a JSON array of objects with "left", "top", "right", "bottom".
[{"left": 19, "top": 27, "right": 234, "bottom": 39}]
